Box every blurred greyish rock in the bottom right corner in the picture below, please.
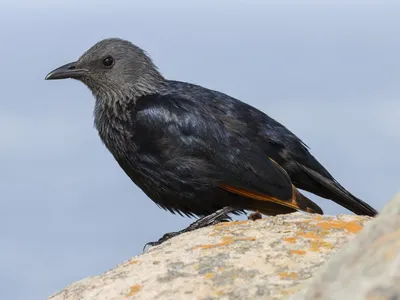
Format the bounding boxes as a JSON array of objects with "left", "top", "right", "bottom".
[{"left": 293, "top": 193, "right": 400, "bottom": 300}]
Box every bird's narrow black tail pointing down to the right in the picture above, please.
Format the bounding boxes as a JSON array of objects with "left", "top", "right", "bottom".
[{"left": 296, "top": 166, "right": 378, "bottom": 217}]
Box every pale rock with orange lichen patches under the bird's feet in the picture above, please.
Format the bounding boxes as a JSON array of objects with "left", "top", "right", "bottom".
[{"left": 49, "top": 212, "right": 372, "bottom": 300}]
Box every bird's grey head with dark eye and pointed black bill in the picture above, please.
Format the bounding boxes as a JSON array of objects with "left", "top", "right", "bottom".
[{"left": 45, "top": 38, "right": 164, "bottom": 101}]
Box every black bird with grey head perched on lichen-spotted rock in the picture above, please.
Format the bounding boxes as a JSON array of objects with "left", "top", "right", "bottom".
[{"left": 46, "top": 38, "right": 377, "bottom": 244}]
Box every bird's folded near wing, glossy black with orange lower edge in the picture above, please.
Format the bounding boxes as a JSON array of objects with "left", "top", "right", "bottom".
[{"left": 134, "top": 94, "right": 322, "bottom": 214}]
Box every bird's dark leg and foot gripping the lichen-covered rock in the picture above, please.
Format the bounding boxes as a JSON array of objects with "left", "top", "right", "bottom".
[{"left": 143, "top": 206, "right": 237, "bottom": 251}]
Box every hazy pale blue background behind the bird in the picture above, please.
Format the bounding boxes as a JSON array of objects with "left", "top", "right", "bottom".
[{"left": 0, "top": 0, "right": 400, "bottom": 300}]
